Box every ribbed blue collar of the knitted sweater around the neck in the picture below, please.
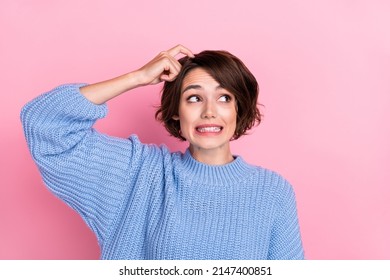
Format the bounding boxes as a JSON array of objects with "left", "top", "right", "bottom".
[{"left": 176, "top": 149, "right": 256, "bottom": 186}]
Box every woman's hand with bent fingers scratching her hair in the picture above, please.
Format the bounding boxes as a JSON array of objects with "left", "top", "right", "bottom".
[{"left": 138, "top": 45, "right": 194, "bottom": 85}]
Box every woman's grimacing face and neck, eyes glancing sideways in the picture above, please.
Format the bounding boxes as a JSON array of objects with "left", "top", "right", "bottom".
[{"left": 174, "top": 68, "right": 237, "bottom": 160}]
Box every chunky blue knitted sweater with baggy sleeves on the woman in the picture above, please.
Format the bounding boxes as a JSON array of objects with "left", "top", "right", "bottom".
[{"left": 21, "top": 84, "right": 304, "bottom": 259}]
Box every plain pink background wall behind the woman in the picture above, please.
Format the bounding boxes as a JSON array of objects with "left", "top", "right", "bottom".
[{"left": 0, "top": 0, "right": 390, "bottom": 259}]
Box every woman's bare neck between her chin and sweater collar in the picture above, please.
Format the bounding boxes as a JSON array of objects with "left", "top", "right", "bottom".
[{"left": 190, "top": 146, "right": 234, "bottom": 165}]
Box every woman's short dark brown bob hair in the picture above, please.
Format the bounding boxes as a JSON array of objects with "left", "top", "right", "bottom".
[{"left": 155, "top": 50, "right": 261, "bottom": 141}]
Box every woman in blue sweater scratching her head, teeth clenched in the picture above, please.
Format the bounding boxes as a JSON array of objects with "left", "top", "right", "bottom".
[{"left": 21, "top": 45, "right": 304, "bottom": 259}]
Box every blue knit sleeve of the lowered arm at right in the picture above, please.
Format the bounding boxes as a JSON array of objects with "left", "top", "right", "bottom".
[{"left": 268, "top": 178, "right": 304, "bottom": 260}]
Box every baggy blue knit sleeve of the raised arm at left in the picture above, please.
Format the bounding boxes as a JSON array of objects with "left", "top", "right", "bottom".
[{"left": 21, "top": 84, "right": 142, "bottom": 244}]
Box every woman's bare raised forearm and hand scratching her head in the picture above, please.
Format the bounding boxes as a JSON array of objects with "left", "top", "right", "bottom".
[{"left": 80, "top": 45, "right": 194, "bottom": 104}]
